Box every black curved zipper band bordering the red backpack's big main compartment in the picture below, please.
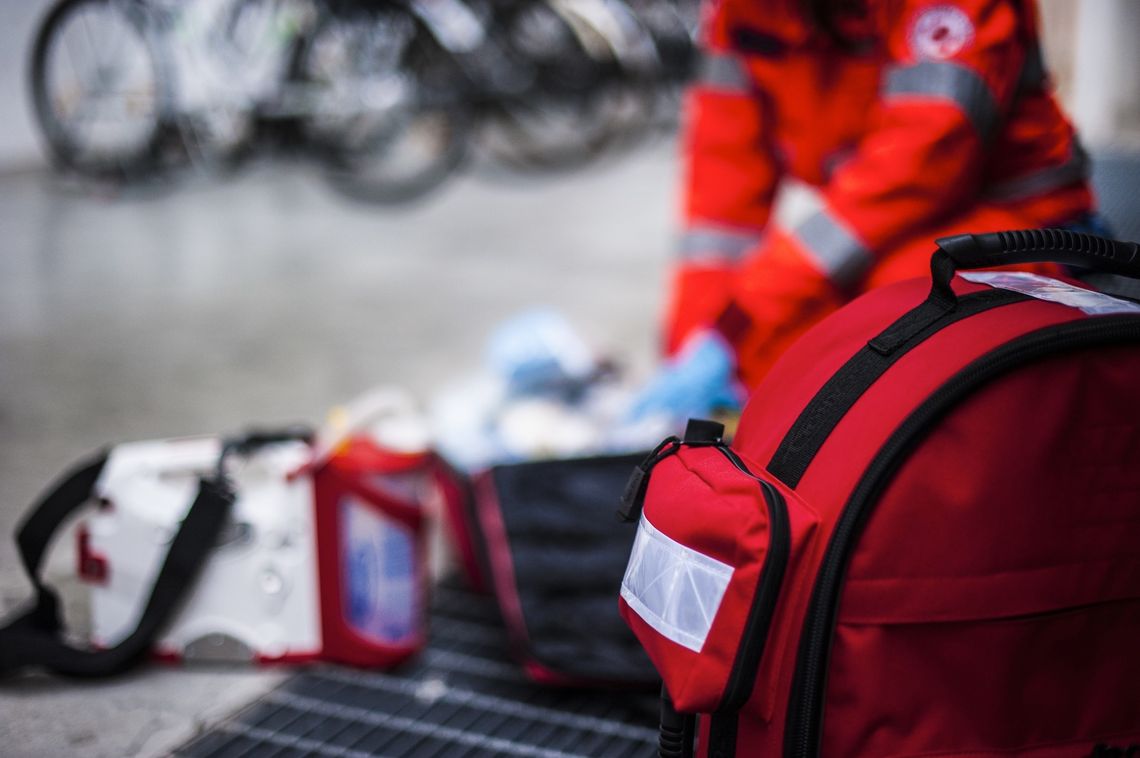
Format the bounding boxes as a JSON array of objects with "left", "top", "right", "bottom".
[{"left": 784, "top": 316, "right": 1140, "bottom": 758}]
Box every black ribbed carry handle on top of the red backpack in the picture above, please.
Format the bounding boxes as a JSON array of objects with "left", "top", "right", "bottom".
[{"left": 930, "top": 229, "right": 1140, "bottom": 307}]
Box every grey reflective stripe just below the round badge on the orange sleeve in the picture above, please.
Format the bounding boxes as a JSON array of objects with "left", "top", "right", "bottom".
[{"left": 882, "top": 60, "right": 999, "bottom": 141}]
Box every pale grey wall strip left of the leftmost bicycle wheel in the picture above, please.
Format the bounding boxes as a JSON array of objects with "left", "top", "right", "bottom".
[{"left": 0, "top": 0, "right": 51, "bottom": 170}]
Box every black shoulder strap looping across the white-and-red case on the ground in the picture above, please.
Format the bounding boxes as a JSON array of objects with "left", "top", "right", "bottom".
[{"left": 0, "top": 451, "right": 234, "bottom": 677}]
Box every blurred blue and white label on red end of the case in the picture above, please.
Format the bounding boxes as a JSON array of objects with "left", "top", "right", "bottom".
[{"left": 340, "top": 496, "right": 420, "bottom": 644}]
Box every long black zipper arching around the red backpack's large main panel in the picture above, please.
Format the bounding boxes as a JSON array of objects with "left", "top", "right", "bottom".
[{"left": 785, "top": 317, "right": 1140, "bottom": 758}]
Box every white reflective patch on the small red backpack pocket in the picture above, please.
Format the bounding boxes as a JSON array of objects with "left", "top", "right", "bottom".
[{"left": 621, "top": 513, "right": 733, "bottom": 653}]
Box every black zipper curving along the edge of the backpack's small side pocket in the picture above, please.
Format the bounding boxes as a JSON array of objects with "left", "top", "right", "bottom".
[{"left": 717, "top": 446, "right": 791, "bottom": 710}]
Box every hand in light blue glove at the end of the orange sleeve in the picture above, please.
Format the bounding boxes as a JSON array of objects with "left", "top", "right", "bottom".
[{"left": 627, "top": 329, "right": 744, "bottom": 422}]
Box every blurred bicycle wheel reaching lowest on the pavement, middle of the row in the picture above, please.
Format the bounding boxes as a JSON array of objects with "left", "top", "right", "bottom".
[{"left": 301, "top": 7, "right": 470, "bottom": 204}]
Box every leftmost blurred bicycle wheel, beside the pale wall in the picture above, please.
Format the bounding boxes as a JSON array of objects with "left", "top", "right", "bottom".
[{"left": 30, "top": 0, "right": 166, "bottom": 179}]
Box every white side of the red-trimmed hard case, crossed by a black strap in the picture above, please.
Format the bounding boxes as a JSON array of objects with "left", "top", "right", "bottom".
[{"left": 87, "top": 438, "right": 321, "bottom": 661}]
